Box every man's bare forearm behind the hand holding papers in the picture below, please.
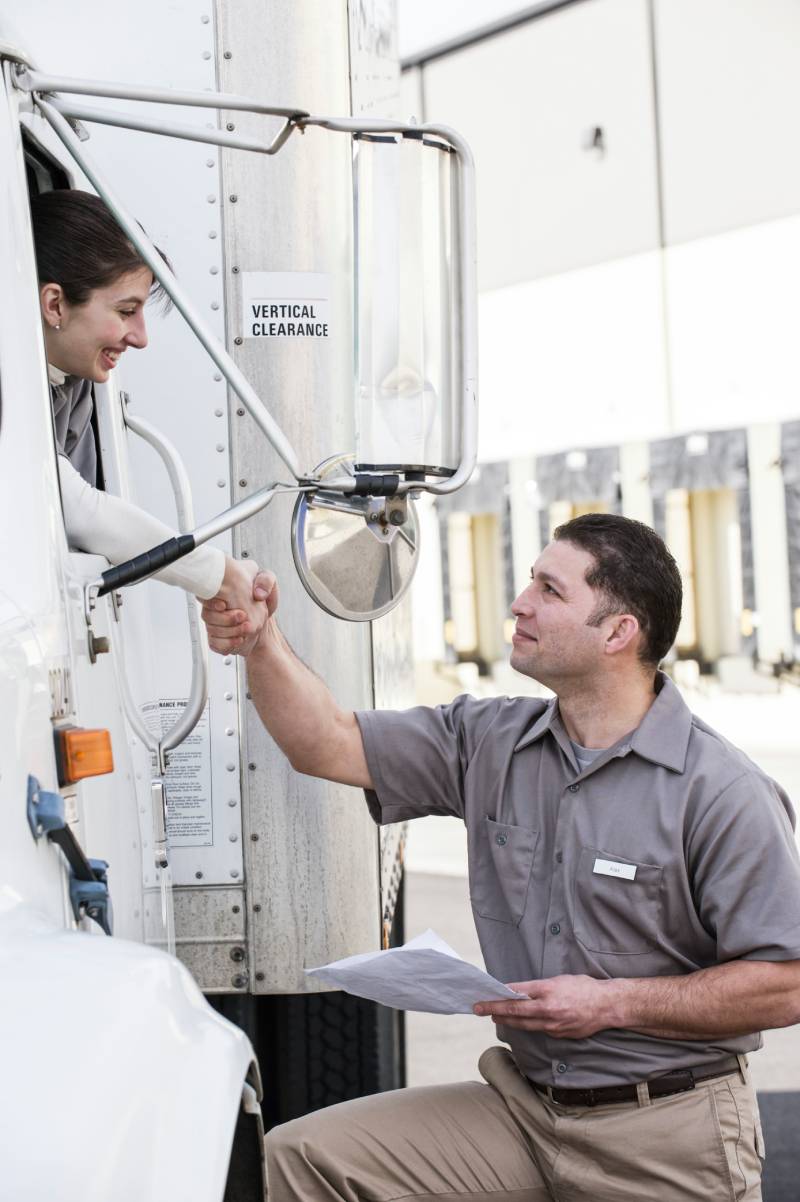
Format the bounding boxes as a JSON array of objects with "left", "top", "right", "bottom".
[{"left": 604, "top": 960, "right": 800, "bottom": 1040}]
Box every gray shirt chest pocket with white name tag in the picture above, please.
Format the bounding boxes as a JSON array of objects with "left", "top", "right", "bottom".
[{"left": 574, "top": 847, "right": 663, "bottom": 956}]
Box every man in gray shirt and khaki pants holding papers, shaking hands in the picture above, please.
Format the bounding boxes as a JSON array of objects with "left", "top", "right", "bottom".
[{"left": 200, "top": 514, "right": 800, "bottom": 1202}]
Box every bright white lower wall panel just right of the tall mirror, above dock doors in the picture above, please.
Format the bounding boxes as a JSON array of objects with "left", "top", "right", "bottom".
[{"left": 479, "top": 252, "right": 670, "bottom": 462}]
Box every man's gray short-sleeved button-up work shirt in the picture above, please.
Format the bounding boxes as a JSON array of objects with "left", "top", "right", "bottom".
[{"left": 357, "top": 674, "right": 800, "bottom": 1089}]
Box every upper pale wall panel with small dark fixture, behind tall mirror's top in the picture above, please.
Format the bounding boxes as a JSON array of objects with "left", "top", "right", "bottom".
[{"left": 423, "top": 0, "right": 658, "bottom": 291}]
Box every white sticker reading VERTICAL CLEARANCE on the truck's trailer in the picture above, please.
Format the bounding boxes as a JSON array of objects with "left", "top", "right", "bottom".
[{"left": 241, "top": 272, "right": 330, "bottom": 341}]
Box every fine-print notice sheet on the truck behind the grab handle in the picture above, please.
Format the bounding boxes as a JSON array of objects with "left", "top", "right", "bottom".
[{"left": 142, "top": 698, "right": 214, "bottom": 847}]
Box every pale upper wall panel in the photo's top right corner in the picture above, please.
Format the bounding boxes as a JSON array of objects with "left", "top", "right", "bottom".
[{"left": 653, "top": 0, "right": 800, "bottom": 243}]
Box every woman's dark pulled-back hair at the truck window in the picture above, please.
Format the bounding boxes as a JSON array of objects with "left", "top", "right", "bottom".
[{"left": 30, "top": 189, "right": 169, "bottom": 308}]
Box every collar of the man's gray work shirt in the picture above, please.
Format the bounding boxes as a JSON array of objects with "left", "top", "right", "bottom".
[{"left": 514, "top": 672, "right": 692, "bottom": 772}]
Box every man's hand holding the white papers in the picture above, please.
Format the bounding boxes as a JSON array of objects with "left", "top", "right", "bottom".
[{"left": 472, "top": 976, "right": 615, "bottom": 1040}]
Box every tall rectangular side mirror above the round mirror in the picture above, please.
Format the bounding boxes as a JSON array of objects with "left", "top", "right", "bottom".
[{"left": 353, "top": 133, "right": 464, "bottom": 482}]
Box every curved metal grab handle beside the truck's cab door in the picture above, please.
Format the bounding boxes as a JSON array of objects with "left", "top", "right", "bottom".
[{"left": 121, "top": 409, "right": 208, "bottom": 754}]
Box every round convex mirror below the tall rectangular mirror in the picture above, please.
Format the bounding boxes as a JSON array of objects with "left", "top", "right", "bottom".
[{"left": 292, "top": 457, "right": 419, "bottom": 621}]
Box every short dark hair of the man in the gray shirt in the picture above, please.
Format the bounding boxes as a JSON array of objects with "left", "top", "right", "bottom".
[{"left": 553, "top": 513, "right": 683, "bottom": 667}]
